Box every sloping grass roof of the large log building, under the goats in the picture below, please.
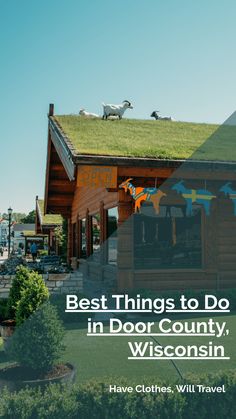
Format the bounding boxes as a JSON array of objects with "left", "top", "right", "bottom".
[{"left": 54, "top": 115, "right": 236, "bottom": 161}]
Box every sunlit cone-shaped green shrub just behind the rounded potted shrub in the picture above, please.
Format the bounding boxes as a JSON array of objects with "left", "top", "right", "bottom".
[{"left": 15, "top": 271, "right": 49, "bottom": 326}]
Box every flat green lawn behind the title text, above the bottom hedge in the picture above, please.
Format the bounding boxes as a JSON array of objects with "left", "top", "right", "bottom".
[{"left": 0, "top": 315, "right": 236, "bottom": 383}]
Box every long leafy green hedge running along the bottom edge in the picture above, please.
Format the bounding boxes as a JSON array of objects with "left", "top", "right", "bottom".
[{"left": 0, "top": 372, "right": 236, "bottom": 419}]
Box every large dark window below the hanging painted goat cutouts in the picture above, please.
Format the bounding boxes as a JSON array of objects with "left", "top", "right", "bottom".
[{"left": 134, "top": 205, "right": 202, "bottom": 269}]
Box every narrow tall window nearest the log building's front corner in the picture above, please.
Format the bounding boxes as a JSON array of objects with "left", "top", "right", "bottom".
[{"left": 107, "top": 207, "right": 118, "bottom": 265}]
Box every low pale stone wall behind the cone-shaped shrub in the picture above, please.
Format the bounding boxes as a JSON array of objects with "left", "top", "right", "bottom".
[{"left": 0, "top": 272, "right": 83, "bottom": 298}]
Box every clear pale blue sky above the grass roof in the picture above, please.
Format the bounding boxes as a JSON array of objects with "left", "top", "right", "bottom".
[{"left": 0, "top": 0, "right": 236, "bottom": 213}]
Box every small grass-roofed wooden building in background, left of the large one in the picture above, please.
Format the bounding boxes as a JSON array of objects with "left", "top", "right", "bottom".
[{"left": 35, "top": 196, "right": 63, "bottom": 254}]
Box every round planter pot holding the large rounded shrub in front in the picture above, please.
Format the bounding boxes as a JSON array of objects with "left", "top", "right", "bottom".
[{"left": 0, "top": 363, "right": 76, "bottom": 391}]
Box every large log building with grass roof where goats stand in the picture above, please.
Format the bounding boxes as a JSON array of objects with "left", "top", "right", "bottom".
[{"left": 45, "top": 105, "right": 236, "bottom": 290}]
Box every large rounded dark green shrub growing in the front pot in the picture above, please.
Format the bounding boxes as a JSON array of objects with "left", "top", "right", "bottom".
[{"left": 9, "top": 302, "right": 64, "bottom": 372}]
